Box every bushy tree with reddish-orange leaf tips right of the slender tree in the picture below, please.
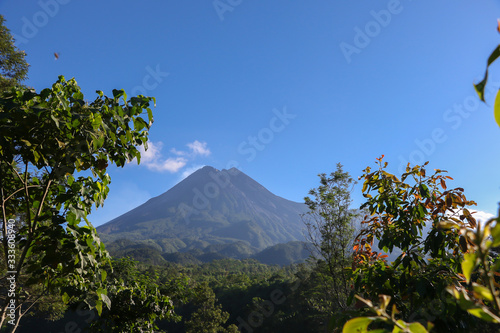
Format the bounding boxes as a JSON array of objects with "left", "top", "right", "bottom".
[{"left": 344, "top": 156, "right": 477, "bottom": 332}]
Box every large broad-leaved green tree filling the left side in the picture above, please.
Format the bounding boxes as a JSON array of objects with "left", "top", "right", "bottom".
[{"left": 0, "top": 76, "right": 158, "bottom": 331}]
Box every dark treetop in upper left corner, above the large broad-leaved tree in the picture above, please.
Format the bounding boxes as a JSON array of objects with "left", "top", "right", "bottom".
[{"left": 0, "top": 15, "right": 29, "bottom": 91}]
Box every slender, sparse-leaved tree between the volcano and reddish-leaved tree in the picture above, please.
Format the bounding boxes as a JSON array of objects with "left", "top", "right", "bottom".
[{"left": 303, "top": 163, "right": 356, "bottom": 313}]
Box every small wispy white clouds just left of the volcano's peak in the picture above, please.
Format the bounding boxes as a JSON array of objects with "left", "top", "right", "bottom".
[{"left": 139, "top": 140, "right": 211, "bottom": 172}]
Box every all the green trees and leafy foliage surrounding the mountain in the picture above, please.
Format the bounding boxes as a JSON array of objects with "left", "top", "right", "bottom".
[{"left": 0, "top": 5, "right": 500, "bottom": 333}]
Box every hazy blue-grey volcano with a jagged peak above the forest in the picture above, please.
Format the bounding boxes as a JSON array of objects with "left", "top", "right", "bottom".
[{"left": 97, "top": 166, "right": 307, "bottom": 257}]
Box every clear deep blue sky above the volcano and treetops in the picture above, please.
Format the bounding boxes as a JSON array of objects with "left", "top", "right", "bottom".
[{"left": 0, "top": 0, "right": 500, "bottom": 226}]
